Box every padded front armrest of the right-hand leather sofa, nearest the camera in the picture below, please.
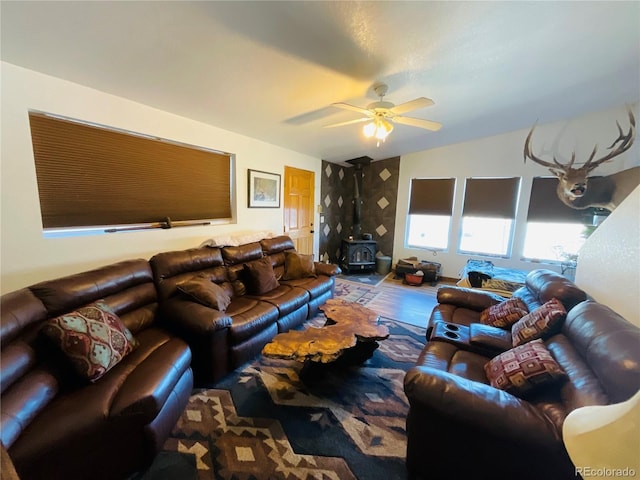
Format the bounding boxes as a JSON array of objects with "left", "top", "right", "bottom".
[{"left": 404, "top": 366, "right": 561, "bottom": 445}]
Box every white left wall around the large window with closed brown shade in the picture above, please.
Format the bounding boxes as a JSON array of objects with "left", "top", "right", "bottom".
[{"left": 0, "top": 62, "right": 321, "bottom": 292}]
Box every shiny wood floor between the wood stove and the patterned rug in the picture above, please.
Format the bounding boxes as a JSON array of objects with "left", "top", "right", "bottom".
[{"left": 338, "top": 274, "right": 453, "bottom": 327}]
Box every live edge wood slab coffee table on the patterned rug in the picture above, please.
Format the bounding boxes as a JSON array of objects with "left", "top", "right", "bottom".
[{"left": 262, "top": 299, "right": 389, "bottom": 366}]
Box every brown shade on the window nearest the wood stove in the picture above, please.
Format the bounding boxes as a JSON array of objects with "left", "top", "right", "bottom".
[{"left": 409, "top": 178, "right": 456, "bottom": 216}]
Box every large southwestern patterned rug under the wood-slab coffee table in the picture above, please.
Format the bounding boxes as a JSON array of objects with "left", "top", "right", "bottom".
[{"left": 164, "top": 315, "right": 425, "bottom": 480}]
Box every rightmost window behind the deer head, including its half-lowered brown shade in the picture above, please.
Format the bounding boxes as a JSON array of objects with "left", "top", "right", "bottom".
[{"left": 523, "top": 177, "right": 593, "bottom": 262}]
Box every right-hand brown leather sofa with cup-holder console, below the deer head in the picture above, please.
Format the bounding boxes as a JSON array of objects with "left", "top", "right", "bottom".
[{"left": 405, "top": 270, "right": 640, "bottom": 479}]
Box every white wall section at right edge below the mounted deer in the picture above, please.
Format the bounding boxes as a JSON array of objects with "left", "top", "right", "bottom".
[{"left": 576, "top": 187, "right": 640, "bottom": 326}]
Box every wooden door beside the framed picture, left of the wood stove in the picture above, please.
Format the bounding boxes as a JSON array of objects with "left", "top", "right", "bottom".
[{"left": 284, "top": 166, "right": 315, "bottom": 254}]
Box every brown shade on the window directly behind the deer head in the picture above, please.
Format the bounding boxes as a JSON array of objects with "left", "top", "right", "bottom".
[{"left": 527, "top": 177, "right": 593, "bottom": 224}]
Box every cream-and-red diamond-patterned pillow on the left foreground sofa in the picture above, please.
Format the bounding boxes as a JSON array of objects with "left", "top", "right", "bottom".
[{"left": 42, "top": 300, "right": 138, "bottom": 382}]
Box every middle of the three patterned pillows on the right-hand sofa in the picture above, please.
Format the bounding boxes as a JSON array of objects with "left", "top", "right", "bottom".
[{"left": 511, "top": 298, "right": 567, "bottom": 347}]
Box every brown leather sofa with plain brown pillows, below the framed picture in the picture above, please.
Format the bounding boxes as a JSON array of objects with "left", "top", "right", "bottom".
[{"left": 150, "top": 235, "right": 340, "bottom": 386}]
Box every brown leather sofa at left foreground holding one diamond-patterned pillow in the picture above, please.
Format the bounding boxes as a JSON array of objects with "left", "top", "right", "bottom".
[{"left": 0, "top": 260, "right": 193, "bottom": 480}]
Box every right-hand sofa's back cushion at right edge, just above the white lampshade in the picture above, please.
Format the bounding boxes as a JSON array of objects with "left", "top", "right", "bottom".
[{"left": 562, "top": 301, "right": 640, "bottom": 403}]
